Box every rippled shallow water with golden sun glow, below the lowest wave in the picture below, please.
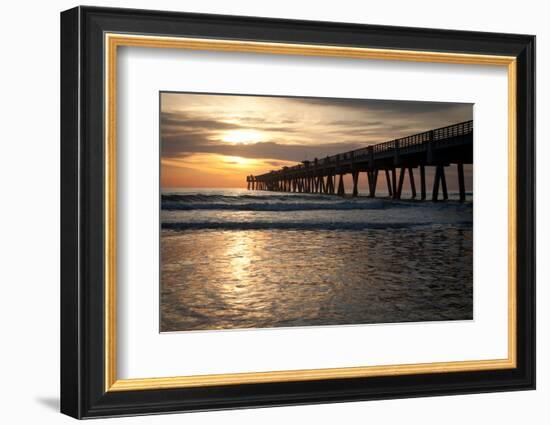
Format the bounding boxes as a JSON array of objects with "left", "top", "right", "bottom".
[{"left": 161, "top": 225, "right": 472, "bottom": 331}]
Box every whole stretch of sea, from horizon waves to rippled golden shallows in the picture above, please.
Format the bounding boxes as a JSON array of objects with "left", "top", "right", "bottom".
[{"left": 161, "top": 189, "right": 473, "bottom": 331}]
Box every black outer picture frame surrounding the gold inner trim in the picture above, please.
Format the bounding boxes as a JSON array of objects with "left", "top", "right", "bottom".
[{"left": 61, "top": 7, "right": 535, "bottom": 418}]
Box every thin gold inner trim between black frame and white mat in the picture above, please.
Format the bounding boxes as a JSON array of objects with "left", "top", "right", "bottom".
[{"left": 104, "top": 33, "right": 517, "bottom": 391}]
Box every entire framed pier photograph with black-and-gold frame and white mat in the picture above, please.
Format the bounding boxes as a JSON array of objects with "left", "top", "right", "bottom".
[{"left": 61, "top": 7, "right": 535, "bottom": 418}]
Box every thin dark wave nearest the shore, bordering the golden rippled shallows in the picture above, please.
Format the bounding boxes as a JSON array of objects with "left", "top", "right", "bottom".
[{"left": 162, "top": 221, "right": 472, "bottom": 231}]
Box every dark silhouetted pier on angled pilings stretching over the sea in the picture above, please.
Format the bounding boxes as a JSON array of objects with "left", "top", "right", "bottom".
[{"left": 246, "top": 121, "right": 473, "bottom": 201}]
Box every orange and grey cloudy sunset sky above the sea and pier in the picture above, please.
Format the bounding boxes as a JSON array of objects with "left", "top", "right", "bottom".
[{"left": 160, "top": 93, "right": 473, "bottom": 190}]
